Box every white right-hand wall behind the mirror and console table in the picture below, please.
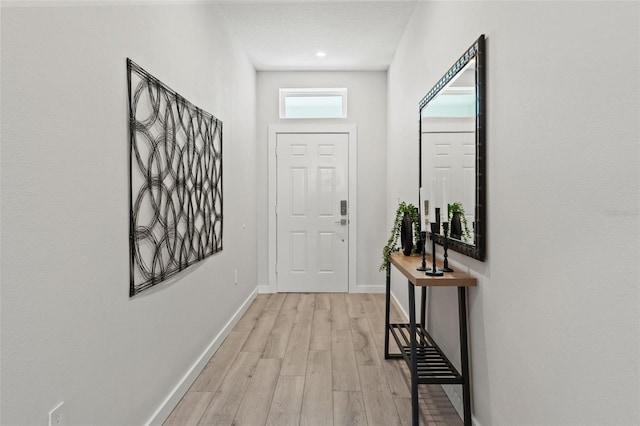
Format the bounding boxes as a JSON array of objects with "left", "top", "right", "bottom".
[{"left": 387, "top": 1, "right": 640, "bottom": 426}]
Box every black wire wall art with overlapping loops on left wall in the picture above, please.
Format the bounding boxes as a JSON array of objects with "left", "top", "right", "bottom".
[{"left": 127, "top": 59, "right": 222, "bottom": 296}]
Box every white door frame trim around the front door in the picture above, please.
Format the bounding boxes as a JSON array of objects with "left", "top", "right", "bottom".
[{"left": 263, "top": 124, "right": 358, "bottom": 293}]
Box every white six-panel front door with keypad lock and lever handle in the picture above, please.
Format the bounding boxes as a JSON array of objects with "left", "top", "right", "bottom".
[{"left": 276, "top": 133, "right": 349, "bottom": 292}]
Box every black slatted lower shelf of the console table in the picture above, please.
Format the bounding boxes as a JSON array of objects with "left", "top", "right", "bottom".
[{"left": 389, "top": 323, "right": 464, "bottom": 384}]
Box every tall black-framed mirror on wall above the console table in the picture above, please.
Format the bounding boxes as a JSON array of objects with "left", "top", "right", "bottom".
[{"left": 419, "top": 35, "right": 486, "bottom": 261}]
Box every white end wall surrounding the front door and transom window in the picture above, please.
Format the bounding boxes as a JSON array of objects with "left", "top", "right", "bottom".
[{"left": 257, "top": 71, "right": 387, "bottom": 291}]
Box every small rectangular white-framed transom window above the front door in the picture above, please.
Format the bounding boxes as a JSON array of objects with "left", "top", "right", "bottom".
[{"left": 280, "top": 88, "right": 347, "bottom": 118}]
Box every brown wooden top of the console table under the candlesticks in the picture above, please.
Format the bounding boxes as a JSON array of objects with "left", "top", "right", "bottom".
[{"left": 391, "top": 252, "right": 478, "bottom": 287}]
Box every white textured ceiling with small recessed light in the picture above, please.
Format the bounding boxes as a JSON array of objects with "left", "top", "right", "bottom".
[{"left": 218, "top": 0, "right": 416, "bottom": 71}]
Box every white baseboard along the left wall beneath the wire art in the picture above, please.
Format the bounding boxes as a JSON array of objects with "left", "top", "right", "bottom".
[{"left": 145, "top": 288, "right": 258, "bottom": 426}]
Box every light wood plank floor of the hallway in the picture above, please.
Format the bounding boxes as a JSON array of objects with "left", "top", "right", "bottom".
[{"left": 165, "top": 293, "right": 462, "bottom": 426}]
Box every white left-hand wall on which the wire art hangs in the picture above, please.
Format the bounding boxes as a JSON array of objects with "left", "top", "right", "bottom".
[{"left": 0, "top": 2, "right": 256, "bottom": 425}]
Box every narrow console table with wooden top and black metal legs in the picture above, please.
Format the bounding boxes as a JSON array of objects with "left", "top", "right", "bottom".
[{"left": 384, "top": 253, "right": 477, "bottom": 426}]
